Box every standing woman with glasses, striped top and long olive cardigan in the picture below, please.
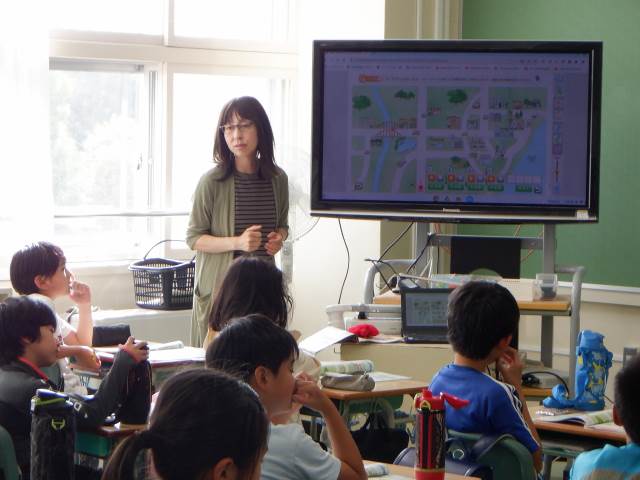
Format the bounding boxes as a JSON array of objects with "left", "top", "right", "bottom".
[{"left": 186, "top": 97, "right": 289, "bottom": 347}]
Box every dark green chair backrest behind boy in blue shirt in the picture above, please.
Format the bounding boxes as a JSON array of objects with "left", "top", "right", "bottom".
[{"left": 449, "top": 430, "right": 537, "bottom": 480}]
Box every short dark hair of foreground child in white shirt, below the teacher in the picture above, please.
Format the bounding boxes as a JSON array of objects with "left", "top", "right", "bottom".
[{"left": 206, "top": 314, "right": 298, "bottom": 383}]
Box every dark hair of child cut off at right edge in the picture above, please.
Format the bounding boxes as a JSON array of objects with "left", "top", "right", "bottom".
[{"left": 614, "top": 355, "right": 640, "bottom": 444}]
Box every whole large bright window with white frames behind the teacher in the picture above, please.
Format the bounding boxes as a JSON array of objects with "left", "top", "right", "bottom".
[{"left": 45, "top": 0, "right": 295, "bottom": 262}]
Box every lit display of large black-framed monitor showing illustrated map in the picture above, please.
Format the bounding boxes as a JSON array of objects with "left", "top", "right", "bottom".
[{"left": 320, "top": 51, "right": 591, "bottom": 208}]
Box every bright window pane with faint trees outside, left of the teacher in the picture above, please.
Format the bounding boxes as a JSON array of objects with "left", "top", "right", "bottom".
[{"left": 49, "top": 59, "right": 161, "bottom": 261}]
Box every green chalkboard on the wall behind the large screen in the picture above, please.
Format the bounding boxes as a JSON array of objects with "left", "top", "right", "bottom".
[{"left": 459, "top": 0, "right": 640, "bottom": 287}]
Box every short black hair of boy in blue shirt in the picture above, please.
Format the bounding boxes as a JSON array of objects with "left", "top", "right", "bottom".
[{"left": 447, "top": 282, "right": 520, "bottom": 360}]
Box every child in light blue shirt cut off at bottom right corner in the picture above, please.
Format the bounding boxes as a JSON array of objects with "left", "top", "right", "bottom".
[{"left": 570, "top": 355, "right": 640, "bottom": 480}]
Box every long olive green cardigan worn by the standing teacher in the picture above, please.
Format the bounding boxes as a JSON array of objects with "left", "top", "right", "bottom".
[{"left": 186, "top": 167, "right": 289, "bottom": 347}]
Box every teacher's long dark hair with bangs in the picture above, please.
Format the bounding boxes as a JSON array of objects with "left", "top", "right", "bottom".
[{"left": 213, "top": 97, "right": 278, "bottom": 180}]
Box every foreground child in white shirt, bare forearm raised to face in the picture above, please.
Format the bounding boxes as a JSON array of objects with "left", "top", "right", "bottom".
[{"left": 206, "top": 315, "right": 367, "bottom": 480}]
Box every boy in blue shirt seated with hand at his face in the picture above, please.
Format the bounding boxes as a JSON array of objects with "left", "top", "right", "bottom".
[{"left": 430, "top": 282, "right": 542, "bottom": 471}]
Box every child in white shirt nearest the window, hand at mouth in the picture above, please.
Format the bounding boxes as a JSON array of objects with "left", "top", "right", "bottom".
[{"left": 9, "top": 242, "right": 100, "bottom": 395}]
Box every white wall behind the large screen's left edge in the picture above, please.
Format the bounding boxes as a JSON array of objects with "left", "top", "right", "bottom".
[{"left": 285, "top": 0, "right": 384, "bottom": 352}]
